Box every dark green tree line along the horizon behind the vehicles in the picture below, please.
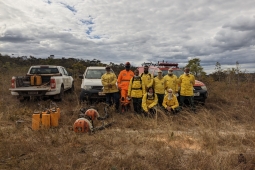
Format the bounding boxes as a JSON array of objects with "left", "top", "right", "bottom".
[{"left": 0, "top": 53, "right": 255, "bottom": 83}]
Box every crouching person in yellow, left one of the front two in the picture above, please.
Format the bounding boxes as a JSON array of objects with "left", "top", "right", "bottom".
[{"left": 142, "top": 87, "right": 158, "bottom": 116}]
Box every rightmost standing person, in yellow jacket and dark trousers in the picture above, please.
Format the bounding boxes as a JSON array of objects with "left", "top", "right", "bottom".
[{"left": 179, "top": 67, "right": 196, "bottom": 113}]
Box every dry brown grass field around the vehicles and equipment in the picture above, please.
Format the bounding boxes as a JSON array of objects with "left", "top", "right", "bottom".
[{"left": 0, "top": 69, "right": 255, "bottom": 170}]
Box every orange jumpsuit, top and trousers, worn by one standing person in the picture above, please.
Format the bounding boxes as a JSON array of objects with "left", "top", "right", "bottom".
[{"left": 118, "top": 70, "right": 134, "bottom": 106}]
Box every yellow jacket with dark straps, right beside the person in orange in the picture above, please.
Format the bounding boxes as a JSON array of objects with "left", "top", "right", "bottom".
[{"left": 128, "top": 76, "right": 145, "bottom": 98}]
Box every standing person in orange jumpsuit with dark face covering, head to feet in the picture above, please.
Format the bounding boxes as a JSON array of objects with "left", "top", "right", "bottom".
[{"left": 118, "top": 62, "right": 134, "bottom": 112}]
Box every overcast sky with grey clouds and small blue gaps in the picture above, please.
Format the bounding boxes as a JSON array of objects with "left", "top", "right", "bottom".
[{"left": 0, "top": 0, "right": 255, "bottom": 73}]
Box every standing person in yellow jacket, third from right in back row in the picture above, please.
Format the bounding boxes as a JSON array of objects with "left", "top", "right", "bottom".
[{"left": 153, "top": 69, "right": 165, "bottom": 106}]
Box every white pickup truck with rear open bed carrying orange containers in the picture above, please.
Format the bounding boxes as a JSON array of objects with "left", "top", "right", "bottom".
[{"left": 9, "top": 65, "right": 74, "bottom": 100}]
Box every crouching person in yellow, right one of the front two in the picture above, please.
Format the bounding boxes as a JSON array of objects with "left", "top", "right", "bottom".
[{"left": 162, "top": 89, "right": 180, "bottom": 114}]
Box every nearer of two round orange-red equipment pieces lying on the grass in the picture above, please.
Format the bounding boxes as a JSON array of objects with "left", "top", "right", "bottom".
[{"left": 73, "top": 118, "right": 93, "bottom": 133}]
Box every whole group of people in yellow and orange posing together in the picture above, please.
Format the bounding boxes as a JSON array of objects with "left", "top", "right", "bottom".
[{"left": 101, "top": 62, "right": 196, "bottom": 116}]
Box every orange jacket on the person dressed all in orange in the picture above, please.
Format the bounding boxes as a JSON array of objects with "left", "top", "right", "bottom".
[{"left": 118, "top": 70, "right": 134, "bottom": 90}]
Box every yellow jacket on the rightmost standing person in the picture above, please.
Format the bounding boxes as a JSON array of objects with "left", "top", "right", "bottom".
[{"left": 179, "top": 73, "right": 195, "bottom": 96}]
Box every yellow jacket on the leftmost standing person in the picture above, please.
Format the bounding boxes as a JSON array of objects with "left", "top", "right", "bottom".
[{"left": 101, "top": 73, "right": 119, "bottom": 93}]
